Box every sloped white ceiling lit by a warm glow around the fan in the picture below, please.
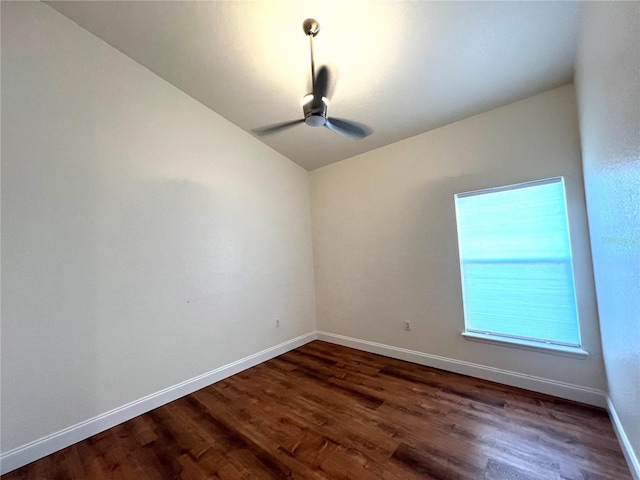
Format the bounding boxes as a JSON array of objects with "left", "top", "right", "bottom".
[{"left": 47, "top": 0, "right": 580, "bottom": 170}]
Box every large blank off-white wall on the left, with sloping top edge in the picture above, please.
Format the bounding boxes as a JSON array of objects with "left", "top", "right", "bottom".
[{"left": 1, "top": 2, "right": 315, "bottom": 452}]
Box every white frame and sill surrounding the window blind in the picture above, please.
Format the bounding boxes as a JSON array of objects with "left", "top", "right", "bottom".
[{"left": 454, "top": 176, "right": 589, "bottom": 358}]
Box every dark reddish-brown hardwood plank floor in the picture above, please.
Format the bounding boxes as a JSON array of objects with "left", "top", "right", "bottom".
[{"left": 2, "top": 341, "right": 631, "bottom": 480}]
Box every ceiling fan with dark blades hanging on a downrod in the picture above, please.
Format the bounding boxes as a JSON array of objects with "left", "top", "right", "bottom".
[{"left": 253, "top": 18, "right": 371, "bottom": 139}]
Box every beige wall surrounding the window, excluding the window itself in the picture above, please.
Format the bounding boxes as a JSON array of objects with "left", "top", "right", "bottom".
[{"left": 311, "top": 85, "right": 605, "bottom": 398}]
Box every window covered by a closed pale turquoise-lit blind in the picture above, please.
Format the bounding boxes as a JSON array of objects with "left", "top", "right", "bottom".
[{"left": 455, "top": 177, "right": 586, "bottom": 355}]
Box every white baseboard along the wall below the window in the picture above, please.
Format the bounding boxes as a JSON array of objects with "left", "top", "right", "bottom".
[{"left": 317, "top": 332, "right": 607, "bottom": 408}]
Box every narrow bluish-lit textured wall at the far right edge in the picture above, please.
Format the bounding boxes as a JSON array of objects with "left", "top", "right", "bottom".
[{"left": 576, "top": 2, "right": 640, "bottom": 472}]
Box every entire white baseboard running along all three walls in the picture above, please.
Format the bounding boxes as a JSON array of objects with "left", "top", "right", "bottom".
[{"left": 0, "top": 332, "right": 624, "bottom": 480}]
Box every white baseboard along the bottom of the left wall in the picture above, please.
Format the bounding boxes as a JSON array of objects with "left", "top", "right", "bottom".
[{"left": 0, "top": 332, "right": 316, "bottom": 475}]
